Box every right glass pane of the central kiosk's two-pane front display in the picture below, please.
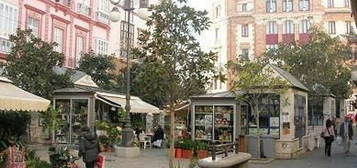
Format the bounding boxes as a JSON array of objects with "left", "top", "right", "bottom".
[{"left": 214, "top": 105, "right": 234, "bottom": 143}]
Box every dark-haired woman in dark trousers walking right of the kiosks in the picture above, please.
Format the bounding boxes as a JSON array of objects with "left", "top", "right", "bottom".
[{"left": 322, "top": 119, "right": 335, "bottom": 157}]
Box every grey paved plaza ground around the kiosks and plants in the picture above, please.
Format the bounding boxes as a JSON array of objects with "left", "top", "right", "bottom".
[{"left": 32, "top": 140, "right": 357, "bottom": 168}]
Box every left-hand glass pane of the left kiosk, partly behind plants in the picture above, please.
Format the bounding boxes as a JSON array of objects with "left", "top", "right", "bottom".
[{"left": 55, "top": 99, "right": 70, "bottom": 143}]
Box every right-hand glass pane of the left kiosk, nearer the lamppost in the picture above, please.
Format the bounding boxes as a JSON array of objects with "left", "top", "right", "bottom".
[{"left": 71, "top": 99, "right": 88, "bottom": 144}]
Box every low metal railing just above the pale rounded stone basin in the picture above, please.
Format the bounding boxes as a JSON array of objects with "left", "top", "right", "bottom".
[{"left": 209, "top": 138, "right": 239, "bottom": 160}]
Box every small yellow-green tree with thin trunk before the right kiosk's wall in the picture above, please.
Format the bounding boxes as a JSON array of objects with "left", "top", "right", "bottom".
[{"left": 228, "top": 59, "right": 288, "bottom": 158}]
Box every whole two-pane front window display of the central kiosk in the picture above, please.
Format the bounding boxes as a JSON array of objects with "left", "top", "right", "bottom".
[{"left": 194, "top": 105, "right": 234, "bottom": 143}]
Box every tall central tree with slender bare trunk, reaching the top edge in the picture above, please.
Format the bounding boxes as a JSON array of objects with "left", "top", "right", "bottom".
[{"left": 133, "top": 0, "right": 216, "bottom": 168}]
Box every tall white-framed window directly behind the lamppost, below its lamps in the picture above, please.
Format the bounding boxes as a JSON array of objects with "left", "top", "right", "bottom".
[{"left": 120, "top": 21, "right": 134, "bottom": 57}]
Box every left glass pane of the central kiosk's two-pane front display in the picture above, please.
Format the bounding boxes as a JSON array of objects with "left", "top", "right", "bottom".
[{"left": 195, "top": 106, "right": 213, "bottom": 140}]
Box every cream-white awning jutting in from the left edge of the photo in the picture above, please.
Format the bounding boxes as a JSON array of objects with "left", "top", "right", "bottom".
[{"left": 0, "top": 76, "right": 50, "bottom": 111}]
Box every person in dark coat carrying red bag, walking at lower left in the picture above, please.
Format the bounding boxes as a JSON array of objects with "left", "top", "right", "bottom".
[{"left": 79, "top": 127, "right": 99, "bottom": 168}]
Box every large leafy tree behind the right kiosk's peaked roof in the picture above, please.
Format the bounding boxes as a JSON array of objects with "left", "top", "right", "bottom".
[{"left": 265, "top": 27, "right": 351, "bottom": 99}]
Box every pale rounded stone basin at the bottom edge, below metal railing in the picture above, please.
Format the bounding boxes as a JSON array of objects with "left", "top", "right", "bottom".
[{"left": 198, "top": 152, "right": 252, "bottom": 168}]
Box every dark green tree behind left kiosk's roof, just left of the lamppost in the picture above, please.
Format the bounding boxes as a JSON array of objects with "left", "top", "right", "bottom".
[{"left": 78, "top": 51, "right": 115, "bottom": 90}]
